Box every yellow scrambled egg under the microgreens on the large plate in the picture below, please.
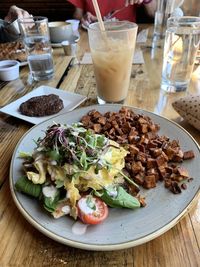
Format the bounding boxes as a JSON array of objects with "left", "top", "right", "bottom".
[{"left": 27, "top": 140, "right": 128, "bottom": 217}]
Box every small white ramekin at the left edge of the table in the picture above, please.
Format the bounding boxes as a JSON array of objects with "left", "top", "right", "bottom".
[{"left": 0, "top": 60, "right": 20, "bottom": 81}]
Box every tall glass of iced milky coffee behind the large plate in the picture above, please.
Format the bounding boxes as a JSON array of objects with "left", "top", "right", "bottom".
[{"left": 88, "top": 21, "right": 138, "bottom": 104}]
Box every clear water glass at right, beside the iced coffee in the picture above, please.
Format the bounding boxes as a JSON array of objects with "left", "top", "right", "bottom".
[{"left": 161, "top": 17, "right": 200, "bottom": 92}]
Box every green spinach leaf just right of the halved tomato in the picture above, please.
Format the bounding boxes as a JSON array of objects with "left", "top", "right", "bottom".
[{"left": 95, "top": 186, "right": 140, "bottom": 209}]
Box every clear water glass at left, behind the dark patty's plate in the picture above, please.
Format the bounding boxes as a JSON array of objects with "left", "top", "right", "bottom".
[{"left": 19, "top": 17, "right": 54, "bottom": 81}]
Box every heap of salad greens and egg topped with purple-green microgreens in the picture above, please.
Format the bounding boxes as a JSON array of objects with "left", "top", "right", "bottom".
[{"left": 15, "top": 123, "right": 140, "bottom": 222}]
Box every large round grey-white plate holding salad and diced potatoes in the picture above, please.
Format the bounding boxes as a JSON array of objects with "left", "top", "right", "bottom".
[{"left": 10, "top": 105, "right": 200, "bottom": 250}]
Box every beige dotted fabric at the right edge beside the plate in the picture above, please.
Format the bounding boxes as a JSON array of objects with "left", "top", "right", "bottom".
[{"left": 172, "top": 94, "right": 200, "bottom": 130}]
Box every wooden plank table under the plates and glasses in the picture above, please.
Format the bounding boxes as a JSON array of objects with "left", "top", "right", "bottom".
[{"left": 0, "top": 26, "right": 200, "bottom": 267}]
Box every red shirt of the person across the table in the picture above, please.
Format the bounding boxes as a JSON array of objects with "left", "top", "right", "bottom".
[{"left": 68, "top": 0, "right": 136, "bottom": 22}]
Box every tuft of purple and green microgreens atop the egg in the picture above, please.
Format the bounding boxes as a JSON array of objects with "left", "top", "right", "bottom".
[{"left": 36, "top": 123, "right": 109, "bottom": 170}]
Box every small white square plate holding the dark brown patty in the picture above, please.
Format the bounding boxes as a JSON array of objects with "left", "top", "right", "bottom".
[{"left": 0, "top": 85, "right": 86, "bottom": 124}]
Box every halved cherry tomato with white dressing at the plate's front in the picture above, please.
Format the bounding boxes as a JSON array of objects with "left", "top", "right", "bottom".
[{"left": 77, "top": 195, "right": 108, "bottom": 224}]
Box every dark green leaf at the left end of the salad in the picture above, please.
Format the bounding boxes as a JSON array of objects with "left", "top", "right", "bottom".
[{"left": 15, "top": 176, "right": 42, "bottom": 198}]
